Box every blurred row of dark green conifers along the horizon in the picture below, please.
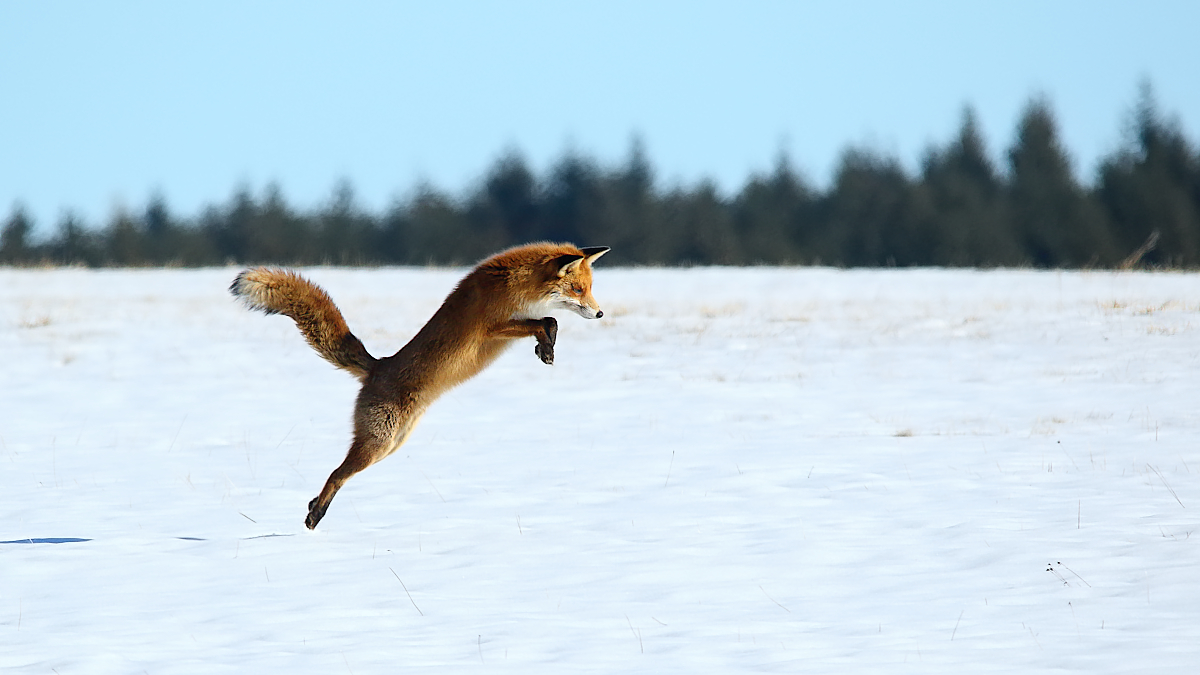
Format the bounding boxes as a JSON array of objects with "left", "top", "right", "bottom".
[{"left": 0, "top": 84, "right": 1200, "bottom": 268}]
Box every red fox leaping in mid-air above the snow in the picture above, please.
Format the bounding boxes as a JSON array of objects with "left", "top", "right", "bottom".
[{"left": 229, "top": 243, "right": 608, "bottom": 530}]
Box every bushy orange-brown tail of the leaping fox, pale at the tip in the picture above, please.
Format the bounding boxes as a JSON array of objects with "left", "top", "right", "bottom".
[{"left": 229, "top": 267, "right": 378, "bottom": 380}]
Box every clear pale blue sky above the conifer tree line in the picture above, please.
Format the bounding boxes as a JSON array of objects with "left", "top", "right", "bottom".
[{"left": 0, "top": 0, "right": 1200, "bottom": 232}]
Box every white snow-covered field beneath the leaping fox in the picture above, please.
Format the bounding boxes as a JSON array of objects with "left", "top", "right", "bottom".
[{"left": 0, "top": 264, "right": 1200, "bottom": 675}]
